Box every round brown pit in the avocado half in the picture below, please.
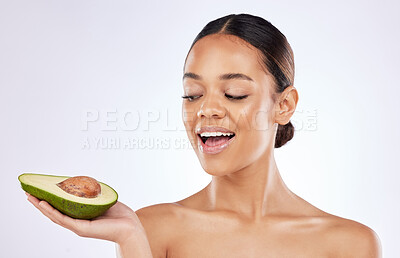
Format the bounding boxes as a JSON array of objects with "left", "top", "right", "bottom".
[{"left": 57, "top": 176, "right": 101, "bottom": 198}]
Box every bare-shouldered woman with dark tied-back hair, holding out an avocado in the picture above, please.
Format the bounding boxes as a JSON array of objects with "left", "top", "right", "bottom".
[{"left": 28, "top": 14, "right": 381, "bottom": 258}]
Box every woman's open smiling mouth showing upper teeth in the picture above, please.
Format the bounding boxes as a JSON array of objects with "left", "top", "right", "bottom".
[{"left": 197, "top": 133, "right": 235, "bottom": 154}]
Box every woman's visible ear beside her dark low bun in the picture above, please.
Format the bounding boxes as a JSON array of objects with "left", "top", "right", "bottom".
[{"left": 275, "top": 86, "right": 299, "bottom": 125}]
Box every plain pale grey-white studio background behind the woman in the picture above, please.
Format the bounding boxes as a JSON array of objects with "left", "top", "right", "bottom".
[{"left": 0, "top": 0, "right": 400, "bottom": 258}]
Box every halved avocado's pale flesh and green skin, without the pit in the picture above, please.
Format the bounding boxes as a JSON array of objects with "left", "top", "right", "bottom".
[{"left": 18, "top": 173, "right": 118, "bottom": 219}]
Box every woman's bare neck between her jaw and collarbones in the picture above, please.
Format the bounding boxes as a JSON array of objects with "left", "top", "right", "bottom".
[{"left": 205, "top": 148, "right": 295, "bottom": 220}]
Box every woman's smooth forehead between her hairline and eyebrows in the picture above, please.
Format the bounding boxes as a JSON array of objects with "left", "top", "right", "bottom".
[{"left": 184, "top": 34, "right": 265, "bottom": 78}]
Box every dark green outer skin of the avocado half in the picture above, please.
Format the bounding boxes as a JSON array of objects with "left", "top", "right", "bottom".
[{"left": 20, "top": 174, "right": 118, "bottom": 219}]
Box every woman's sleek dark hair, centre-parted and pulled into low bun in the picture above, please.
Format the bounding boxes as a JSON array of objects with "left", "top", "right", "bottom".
[{"left": 185, "top": 14, "right": 294, "bottom": 148}]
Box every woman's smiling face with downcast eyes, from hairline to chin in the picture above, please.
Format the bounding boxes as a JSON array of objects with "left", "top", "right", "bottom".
[{"left": 182, "top": 34, "right": 277, "bottom": 176}]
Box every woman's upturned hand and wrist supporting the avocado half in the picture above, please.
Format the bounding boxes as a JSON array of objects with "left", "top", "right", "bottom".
[{"left": 26, "top": 193, "right": 152, "bottom": 257}]
